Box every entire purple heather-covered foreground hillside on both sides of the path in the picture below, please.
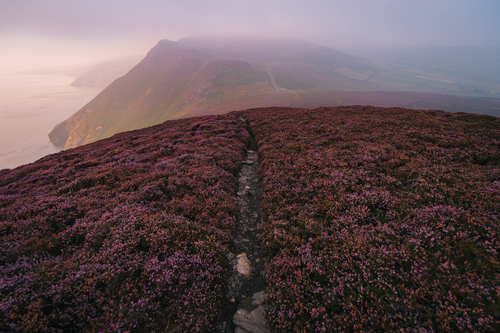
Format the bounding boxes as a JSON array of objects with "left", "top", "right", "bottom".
[{"left": 0, "top": 106, "right": 500, "bottom": 332}]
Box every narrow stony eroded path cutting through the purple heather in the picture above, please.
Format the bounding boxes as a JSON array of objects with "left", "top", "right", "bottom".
[{"left": 220, "top": 118, "right": 269, "bottom": 333}]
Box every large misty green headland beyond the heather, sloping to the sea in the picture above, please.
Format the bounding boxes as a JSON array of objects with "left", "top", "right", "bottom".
[{"left": 49, "top": 38, "right": 500, "bottom": 148}]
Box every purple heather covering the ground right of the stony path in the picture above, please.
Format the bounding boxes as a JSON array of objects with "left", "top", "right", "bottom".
[{"left": 243, "top": 107, "right": 500, "bottom": 332}]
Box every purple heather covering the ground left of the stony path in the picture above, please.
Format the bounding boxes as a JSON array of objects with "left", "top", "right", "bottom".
[{"left": 0, "top": 116, "right": 249, "bottom": 332}]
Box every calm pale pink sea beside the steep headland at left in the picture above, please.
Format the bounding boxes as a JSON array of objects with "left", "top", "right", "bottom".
[{"left": 0, "top": 75, "right": 103, "bottom": 169}]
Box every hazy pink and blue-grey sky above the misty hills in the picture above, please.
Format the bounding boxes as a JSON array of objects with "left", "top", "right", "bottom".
[{"left": 0, "top": 0, "right": 500, "bottom": 71}]
